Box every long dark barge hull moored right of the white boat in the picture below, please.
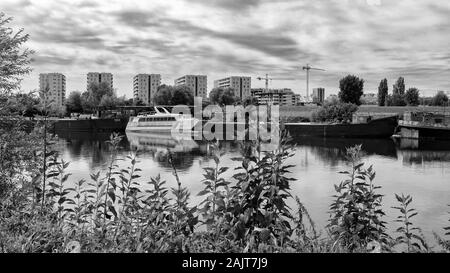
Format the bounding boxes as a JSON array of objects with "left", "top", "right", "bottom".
[{"left": 284, "top": 116, "right": 398, "bottom": 138}]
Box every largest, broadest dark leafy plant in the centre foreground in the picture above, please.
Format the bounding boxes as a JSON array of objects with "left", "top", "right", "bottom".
[{"left": 230, "top": 133, "right": 296, "bottom": 252}]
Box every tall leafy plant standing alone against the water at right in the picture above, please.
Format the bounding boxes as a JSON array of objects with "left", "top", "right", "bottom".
[{"left": 327, "top": 145, "right": 387, "bottom": 251}]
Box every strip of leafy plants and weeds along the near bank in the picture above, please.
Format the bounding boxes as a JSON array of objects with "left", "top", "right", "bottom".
[{"left": 0, "top": 126, "right": 448, "bottom": 253}]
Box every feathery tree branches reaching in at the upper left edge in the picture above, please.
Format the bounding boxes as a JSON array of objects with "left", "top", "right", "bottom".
[{"left": 0, "top": 12, "right": 33, "bottom": 93}]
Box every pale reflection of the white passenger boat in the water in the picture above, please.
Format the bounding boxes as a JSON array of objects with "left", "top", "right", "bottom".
[{"left": 126, "top": 131, "right": 199, "bottom": 152}]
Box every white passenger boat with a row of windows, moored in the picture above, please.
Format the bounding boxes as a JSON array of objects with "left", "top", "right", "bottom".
[{"left": 126, "top": 106, "right": 198, "bottom": 134}]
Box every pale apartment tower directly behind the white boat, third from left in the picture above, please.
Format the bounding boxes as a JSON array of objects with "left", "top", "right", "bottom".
[{"left": 133, "top": 74, "right": 161, "bottom": 105}]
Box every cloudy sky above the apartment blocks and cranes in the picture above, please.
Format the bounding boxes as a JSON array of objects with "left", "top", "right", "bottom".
[{"left": 0, "top": 0, "right": 450, "bottom": 97}]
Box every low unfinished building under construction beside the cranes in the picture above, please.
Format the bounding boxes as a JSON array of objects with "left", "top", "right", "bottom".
[{"left": 251, "top": 88, "right": 300, "bottom": 106}]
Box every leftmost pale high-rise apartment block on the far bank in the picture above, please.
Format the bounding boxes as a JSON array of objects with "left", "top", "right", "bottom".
[{"left": 39, "top": 73, "right": 66, "bottom": 106}]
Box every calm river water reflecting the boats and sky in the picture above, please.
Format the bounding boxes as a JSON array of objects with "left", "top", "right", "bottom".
[{"left": 54, "top": 130, "right": 450, "bottom": 242}]
